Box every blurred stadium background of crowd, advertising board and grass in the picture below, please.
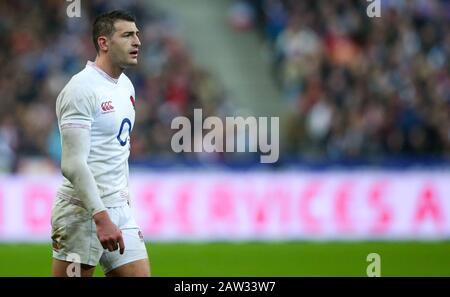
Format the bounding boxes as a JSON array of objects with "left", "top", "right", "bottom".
[{"left": 0, "top": 0, "right": 450, "bottom": 276}]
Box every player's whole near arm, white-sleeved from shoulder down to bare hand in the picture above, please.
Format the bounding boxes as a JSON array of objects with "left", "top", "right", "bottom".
[{"left": 56, "top": 82, "right": 125, "bottom": 254}]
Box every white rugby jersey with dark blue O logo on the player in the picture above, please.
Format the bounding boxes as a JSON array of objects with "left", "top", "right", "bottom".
[{"left": 56, "top": 61, "right": 135, "bottom": 207}]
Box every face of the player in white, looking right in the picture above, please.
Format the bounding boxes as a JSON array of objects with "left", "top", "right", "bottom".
[{"left": 107, "top": 21, "right": 141, "bottom": 69}]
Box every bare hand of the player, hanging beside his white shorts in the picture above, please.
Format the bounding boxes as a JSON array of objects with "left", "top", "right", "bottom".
[{"left": 94, "top": 210, "right": 125, "bottom": 254}]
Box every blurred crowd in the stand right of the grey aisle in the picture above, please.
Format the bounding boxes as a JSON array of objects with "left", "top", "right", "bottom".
[{"left": 243, "top": 0, "right": 450, "bottom": 160}]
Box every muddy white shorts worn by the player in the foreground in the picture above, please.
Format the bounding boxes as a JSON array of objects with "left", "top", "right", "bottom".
[{"left": 52, "top": 199, "right": 148, "bottom": 274}]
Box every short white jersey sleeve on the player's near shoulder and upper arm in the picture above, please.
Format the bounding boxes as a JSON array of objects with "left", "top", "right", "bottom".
[{"left": 56, "top": 85, "right": 96, "bottom": 129}]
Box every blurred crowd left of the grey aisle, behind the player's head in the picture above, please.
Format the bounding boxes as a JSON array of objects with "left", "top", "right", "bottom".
[{"left": 0, "top": 0, "right": 226, "bottom": 172}]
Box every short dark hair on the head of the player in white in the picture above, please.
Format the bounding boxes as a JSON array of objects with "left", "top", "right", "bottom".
[{"left": 92, "top": 10, "right": 136, "bottom": 53}]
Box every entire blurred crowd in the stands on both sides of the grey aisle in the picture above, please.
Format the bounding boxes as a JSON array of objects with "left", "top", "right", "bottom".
[{"left": 0, "top": 0, "right": 450, "bottom": 172}]
